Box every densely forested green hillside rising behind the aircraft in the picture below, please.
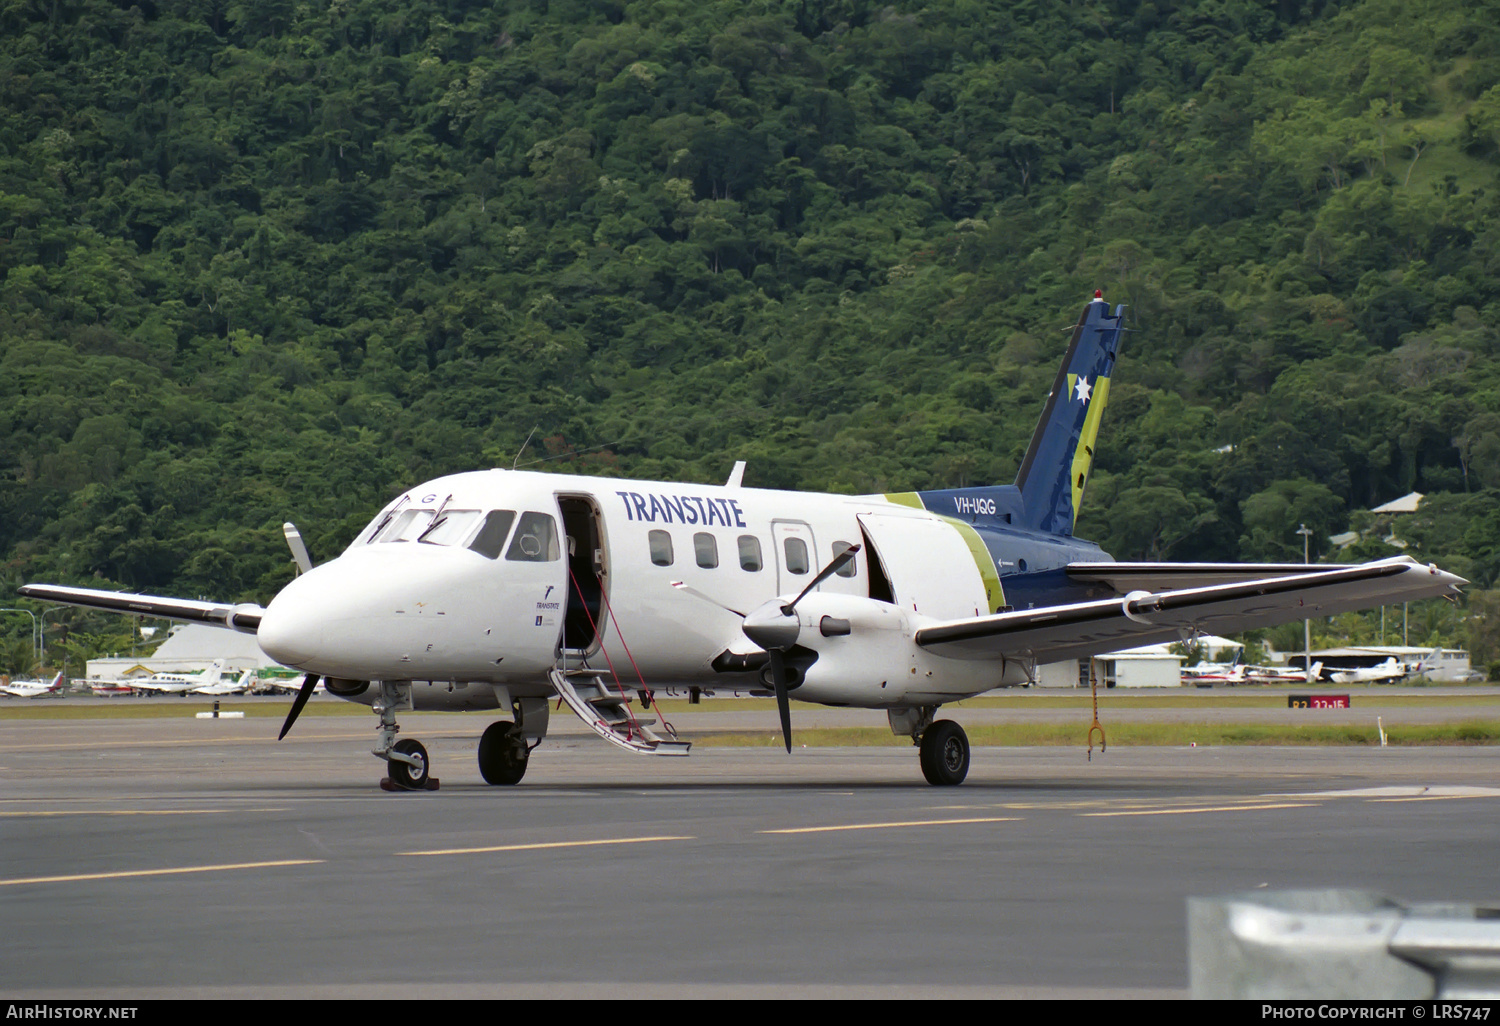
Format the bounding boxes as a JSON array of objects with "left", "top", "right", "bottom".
[{"left": 0, "top": 0, "right": 1500, "bottom": 669}]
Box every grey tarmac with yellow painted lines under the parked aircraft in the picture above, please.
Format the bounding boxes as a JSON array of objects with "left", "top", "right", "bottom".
[{"left": 0, "top": 689, "right": 1500, "bottom": 1001}]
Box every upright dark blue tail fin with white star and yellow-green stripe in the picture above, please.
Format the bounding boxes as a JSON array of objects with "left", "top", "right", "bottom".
[{"left": 1016, "top": 293, "right": 1125, "bottom": 536}]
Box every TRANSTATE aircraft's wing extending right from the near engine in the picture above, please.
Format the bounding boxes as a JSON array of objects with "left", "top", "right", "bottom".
[{"left": 917, "top": 557, "right": 1467, "bottom": 663}]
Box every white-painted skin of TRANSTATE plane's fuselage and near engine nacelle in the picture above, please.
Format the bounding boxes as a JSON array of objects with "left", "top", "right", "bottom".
[{"left": 261, "top": 471, "right": 1010, "bottom": 707}]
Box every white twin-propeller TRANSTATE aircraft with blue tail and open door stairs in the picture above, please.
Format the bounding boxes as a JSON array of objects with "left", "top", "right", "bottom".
[{"left": 21, "top": 294, "right": 1464, "bottom": 789}]
